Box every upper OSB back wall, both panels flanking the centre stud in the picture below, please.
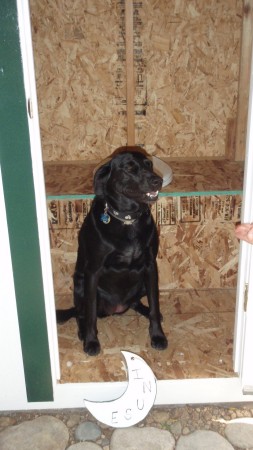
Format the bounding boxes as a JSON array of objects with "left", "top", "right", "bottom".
[{"left": 30, "top": 0, "right": 242, "bottom": 160}]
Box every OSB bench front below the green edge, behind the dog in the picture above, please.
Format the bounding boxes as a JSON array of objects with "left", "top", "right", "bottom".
[{"left": 48, "top": 195, "right": 241, "bottom": 294}]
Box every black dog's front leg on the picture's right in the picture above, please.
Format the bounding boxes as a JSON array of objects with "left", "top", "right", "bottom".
[{"left": 145, "top": 262, "right": 168, "bottom": 350}]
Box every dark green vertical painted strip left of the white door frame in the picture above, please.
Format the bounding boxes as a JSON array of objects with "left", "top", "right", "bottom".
[{"left": 0, "top": 0, "right": 53, "bottom": 402}]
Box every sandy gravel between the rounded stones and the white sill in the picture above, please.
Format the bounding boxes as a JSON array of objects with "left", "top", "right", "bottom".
[{"left": 0, "top": 404, "right": 253, "bottom": 450}]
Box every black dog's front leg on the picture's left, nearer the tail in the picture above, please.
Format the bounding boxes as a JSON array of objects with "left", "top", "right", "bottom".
[{"left": 74, "top": 273, "right": 100, "bottom": 356}]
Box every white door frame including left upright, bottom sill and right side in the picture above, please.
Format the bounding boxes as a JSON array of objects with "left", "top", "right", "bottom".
[{"left": 8, "top": 0, "right": 253, "bottom": 409}]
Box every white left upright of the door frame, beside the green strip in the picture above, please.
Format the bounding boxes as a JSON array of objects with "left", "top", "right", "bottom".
[{"left": 17, "top": 0, "right": 60, "bottom": 380}]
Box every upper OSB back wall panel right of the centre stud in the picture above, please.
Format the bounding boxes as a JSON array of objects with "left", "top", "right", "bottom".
[{"left": 136, "top": 0, "right": 242, "bottom": 158}]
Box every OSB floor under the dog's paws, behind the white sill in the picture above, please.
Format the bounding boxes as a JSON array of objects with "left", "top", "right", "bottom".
[{"left": 57, "top": 289, "right": 236, "bottom": 383}]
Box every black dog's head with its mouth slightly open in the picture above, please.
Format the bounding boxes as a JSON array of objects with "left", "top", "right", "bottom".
[{"left": 94, "top": 147, "right": 162, "bottom": 203}]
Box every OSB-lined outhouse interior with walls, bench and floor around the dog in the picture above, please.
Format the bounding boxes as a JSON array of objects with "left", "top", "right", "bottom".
[{"left": 30, "top": 0, "right": 249, "bottom": 383}]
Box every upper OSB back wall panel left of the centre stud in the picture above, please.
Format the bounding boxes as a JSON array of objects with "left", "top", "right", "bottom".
[{"left": 30, "top": 0, "right": 126, "bottom": 160}]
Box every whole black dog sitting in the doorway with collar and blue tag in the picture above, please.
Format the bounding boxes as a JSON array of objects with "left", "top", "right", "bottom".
[{"left": 57, "top": 147, "right": 168, "bottom": 355}]
